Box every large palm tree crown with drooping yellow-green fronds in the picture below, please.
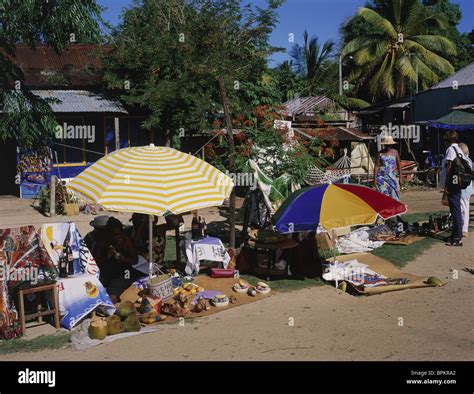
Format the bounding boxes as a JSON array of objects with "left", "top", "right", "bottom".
[{"left": 342, "top": 0, "right": 456, "bottom": 101}]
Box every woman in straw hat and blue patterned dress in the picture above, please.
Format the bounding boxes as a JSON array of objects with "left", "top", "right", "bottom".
[{"left": 374, "top": 136, "right": 402, "bottom": 201}]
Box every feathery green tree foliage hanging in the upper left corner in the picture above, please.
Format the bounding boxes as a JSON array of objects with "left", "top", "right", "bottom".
[{"left": 0, "top": 0, "right": 102, "bottom": 144}]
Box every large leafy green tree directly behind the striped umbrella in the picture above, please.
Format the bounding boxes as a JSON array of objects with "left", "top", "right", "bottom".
[{"left": 103, "top": 0, "right": 282, "bottom": 145}]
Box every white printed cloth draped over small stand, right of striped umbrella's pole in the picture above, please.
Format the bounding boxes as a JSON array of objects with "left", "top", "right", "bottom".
[{"left": 184, "top": 233, "right": 230, "bottom": 275}]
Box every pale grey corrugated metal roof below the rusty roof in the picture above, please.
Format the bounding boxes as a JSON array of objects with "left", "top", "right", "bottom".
[{"left": 31, "top": 90, "right": 128, "bottom": 114}]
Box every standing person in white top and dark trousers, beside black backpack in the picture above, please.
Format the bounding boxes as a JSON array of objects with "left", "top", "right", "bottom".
[{"left": 443, "top": 131, "right": 464, "bottom": 246}]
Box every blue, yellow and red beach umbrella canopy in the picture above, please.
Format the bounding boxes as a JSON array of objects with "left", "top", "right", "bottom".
[{"left": 272, "top": 184, "right": 407, "bottom": 233}]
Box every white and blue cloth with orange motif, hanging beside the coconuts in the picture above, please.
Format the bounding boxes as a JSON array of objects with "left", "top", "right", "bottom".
[{"left": 57, "top": 274, "right": 115, "bottom": 330}]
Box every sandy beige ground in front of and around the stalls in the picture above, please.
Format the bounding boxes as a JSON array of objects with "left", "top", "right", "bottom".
[{"left": 0, "top": 191, "right": 474, "bottom": 361}]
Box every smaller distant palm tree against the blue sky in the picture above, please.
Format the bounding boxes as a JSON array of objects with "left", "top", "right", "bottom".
[{"left": 290, "top": 30, "right": 337, "bottom": 95}]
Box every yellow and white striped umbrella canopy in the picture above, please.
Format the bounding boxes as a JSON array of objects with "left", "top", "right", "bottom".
[{"left": 68, "top": 144, "right": 234, "bottom": 216}]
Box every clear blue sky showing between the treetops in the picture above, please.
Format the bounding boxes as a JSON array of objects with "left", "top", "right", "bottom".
[{"left": 99, "top": 0, "right": 474, "bottom": 66}]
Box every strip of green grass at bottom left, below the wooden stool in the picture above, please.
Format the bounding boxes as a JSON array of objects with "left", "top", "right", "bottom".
[{"left": 0, "top": 333, "right": 71, "bottom": 355}]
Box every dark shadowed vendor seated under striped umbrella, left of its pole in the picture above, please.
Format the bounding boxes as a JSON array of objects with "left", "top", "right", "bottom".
[{"left": 94, "top": 217, "right": 144, "bottom": 303}]
